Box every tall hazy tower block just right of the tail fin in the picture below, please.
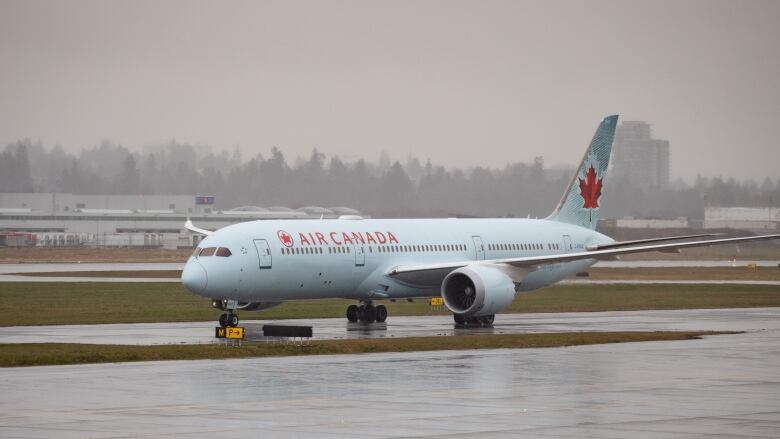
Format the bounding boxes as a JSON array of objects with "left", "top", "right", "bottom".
[{"left": 613, "top": 120, "right": 669, "bottom": 188}]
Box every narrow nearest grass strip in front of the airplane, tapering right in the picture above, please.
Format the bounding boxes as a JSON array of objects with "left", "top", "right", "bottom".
[{"left": 0, "top": 331, "right": 726, "bottom": 367}]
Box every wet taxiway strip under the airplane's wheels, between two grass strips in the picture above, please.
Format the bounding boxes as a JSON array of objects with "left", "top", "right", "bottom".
[{"left": 0, "top": 308, "right": 780, "bottom": 345}]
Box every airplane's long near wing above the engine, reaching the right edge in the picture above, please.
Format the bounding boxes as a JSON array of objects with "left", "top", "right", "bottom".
[{"left": 387, "top": 234, "right": 780, "bottom": 284}]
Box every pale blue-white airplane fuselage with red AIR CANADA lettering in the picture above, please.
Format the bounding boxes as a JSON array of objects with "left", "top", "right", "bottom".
[{"left": 182, "top": 219, "right": 612, "bottom": 302}]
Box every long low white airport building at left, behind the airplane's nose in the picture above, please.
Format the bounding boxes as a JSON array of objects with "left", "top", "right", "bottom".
[{"left": 0, "top": 193, "right": 360, "bottom": 248}]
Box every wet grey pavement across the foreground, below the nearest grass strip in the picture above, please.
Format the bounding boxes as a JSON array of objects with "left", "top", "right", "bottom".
[{"left": 0, "top": 309, "right": 780, "bottom": 438}]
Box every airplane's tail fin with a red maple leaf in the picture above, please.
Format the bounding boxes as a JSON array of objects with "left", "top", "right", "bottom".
[{"left": 547, "top": 115, "right": 618, "bottom": 230}]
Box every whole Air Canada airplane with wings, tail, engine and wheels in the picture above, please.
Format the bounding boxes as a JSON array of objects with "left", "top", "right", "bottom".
[{"left": 181, "top": 116, "right": 780, "bottom": 326}]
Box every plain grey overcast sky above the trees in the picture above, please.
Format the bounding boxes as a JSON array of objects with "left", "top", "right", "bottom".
[{"left": 0, "top": 0, "right": 780, "bottom": 182}]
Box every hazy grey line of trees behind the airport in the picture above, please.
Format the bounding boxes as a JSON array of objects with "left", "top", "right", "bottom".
[{"left": 0, "top": 140, "right": 780, "bottom": 218}]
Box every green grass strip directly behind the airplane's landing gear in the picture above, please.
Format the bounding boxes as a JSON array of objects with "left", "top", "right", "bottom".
[{"left": 0, "top": 282, "right": 780, "bottom": 326}]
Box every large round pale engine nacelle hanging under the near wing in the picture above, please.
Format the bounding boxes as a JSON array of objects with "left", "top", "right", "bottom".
[{"left": 441, "top": 264, "right": 515, "bottom": 317}]
